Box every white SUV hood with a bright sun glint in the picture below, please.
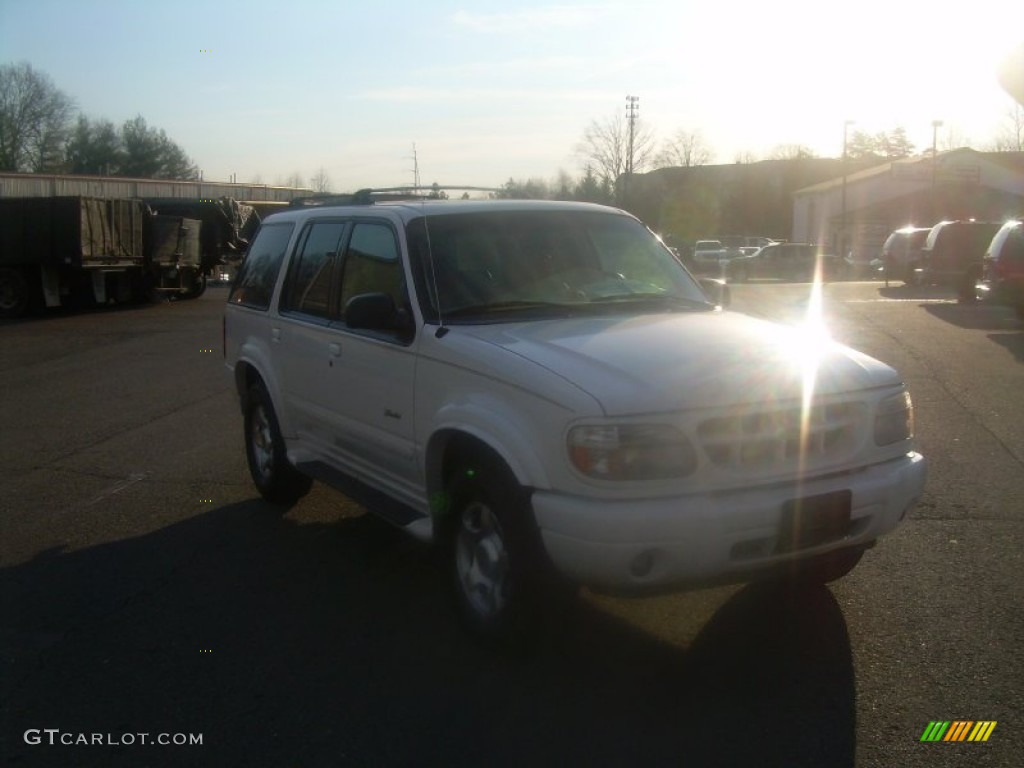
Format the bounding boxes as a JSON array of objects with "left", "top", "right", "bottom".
[{"left": 465, "top": 311, "right": 900, "bottom": 416}]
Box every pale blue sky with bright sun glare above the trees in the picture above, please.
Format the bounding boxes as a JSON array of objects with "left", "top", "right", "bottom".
[{"left": 0, "top": 0, "right": 1024, "bottom": 191}]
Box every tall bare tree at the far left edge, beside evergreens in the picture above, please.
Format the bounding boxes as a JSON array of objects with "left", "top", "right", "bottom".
[{"left": 0, "top": 62, "right": 75, "bottom": 173}]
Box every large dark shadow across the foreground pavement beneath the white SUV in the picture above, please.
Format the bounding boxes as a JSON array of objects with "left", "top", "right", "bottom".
[{"left": 0, "top": 501, "right": 855, "bottom": 766}]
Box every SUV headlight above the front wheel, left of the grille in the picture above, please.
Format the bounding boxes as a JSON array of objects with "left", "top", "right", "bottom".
[{"left": 567, "top": 424, "right": 697, "bottom": 480}]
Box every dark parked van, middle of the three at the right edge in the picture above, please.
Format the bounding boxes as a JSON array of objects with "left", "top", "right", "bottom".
[{"left": 921, "top": 219, "right": 999, "bottom": 301}]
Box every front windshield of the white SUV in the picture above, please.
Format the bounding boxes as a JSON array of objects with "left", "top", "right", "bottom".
[{"left": 408, "top": 210, "right": 713, "bottom": 322}]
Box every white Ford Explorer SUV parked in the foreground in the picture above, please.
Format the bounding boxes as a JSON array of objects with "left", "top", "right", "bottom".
[{"left": 224, "top": 201, "right": 926, "bottom": 637}]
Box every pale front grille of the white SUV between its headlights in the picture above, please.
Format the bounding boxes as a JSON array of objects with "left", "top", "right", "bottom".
[{"left": 697, "top": 402, "right": 867, "bottom": 473}]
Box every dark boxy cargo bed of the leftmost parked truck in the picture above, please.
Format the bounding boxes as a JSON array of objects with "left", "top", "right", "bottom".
[{"left": 0, "top": 197, "right": 145, "bottom": 268}]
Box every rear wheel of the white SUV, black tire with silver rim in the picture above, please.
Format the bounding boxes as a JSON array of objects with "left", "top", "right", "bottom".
[{"left": 245, "top": 383, "right": 312, "bottom": 504}]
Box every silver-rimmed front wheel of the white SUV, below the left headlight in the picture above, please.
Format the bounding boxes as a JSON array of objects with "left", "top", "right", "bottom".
[{"left": 443, "top": 453, "right": 545, "bottom": 647}]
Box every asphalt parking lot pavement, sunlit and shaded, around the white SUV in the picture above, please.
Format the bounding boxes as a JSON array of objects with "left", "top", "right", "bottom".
[{"left": 0, "top": 283, "right": 1024, "bottom": 768}]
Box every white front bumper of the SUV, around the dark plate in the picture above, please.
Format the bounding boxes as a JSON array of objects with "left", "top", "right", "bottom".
[{"left": 532, "top": 453, "right": 928, "bottom": 590}]
